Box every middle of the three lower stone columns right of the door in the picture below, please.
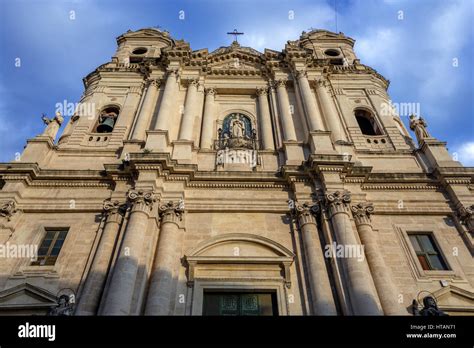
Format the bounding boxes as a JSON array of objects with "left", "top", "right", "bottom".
[{"left": 326, "top": 191, "right": 383, "bottom": 315}]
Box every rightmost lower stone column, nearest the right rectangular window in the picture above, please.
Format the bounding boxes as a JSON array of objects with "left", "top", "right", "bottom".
[{"left": 351, "top": 203, "right": 406, "bottom": 315}]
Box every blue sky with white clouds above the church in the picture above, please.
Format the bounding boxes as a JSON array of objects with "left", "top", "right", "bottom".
[{"left": 0, "top": 0, "right": 474, "bottom": 166}]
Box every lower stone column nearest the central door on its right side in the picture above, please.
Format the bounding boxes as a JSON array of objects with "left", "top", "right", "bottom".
[{"left": 295, "top": 202, "right": 337, "bottom": 315}]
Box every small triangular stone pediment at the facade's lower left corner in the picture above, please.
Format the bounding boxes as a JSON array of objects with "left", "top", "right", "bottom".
[{"left": 0, "top": 283, "right": 57, "bottom": 309}]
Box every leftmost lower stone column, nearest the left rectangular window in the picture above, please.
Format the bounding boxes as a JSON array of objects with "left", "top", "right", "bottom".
[{"left": 76, "top": 200, "right": 124, "bottom": 315}]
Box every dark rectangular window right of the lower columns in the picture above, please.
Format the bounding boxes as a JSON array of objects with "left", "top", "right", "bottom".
[{"left": 409, "top": 233, "right": 449, "bottom": 271}]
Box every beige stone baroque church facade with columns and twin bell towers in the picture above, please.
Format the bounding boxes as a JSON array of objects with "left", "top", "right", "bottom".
[{"left": 0, "top": 28, "right": 474, "bottom": 315}]
